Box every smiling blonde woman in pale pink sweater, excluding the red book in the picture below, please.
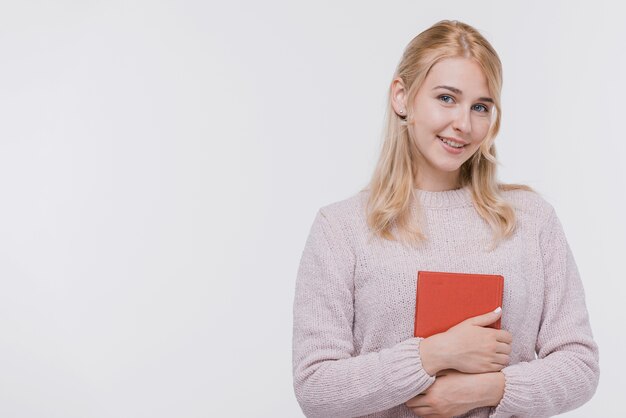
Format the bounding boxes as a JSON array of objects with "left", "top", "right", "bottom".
[{"left": 293, "top": 21, "right": 599, "bottom": 417}]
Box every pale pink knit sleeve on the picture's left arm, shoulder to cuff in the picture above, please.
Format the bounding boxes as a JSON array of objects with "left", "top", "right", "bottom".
[{"left": 293, "top": 210, "right": 435, "bottom": 417}]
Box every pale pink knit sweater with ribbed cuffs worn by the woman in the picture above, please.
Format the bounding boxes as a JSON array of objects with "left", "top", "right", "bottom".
[{"left": 293, "top": 187, "right": 599, "bottom": 418}]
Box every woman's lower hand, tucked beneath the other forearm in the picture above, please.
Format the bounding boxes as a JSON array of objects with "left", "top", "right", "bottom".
[{"left": 405, "top": 370, "right": 498, "bottom": 418}]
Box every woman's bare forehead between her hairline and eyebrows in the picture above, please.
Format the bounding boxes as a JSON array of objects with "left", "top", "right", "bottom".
[{"left": 420, "top": 57, "right": 489, "bottom": 97}]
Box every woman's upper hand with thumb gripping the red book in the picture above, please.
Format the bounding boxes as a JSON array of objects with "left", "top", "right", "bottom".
[{"left": 420, "top": 310, "right": 513, "bottom": 376}]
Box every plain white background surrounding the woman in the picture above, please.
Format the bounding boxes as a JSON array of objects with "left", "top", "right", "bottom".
[{"left": 0, "top": 0, "right": 626, "bottom": 418}]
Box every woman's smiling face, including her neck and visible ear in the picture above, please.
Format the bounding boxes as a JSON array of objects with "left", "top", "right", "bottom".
[{"left": 394, "top": 58, "right": 494, "bottom": 191}]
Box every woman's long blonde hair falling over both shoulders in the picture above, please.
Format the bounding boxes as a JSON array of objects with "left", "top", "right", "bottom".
[{"left": 364, "top": 20, "right": 532, "bottom": 249}]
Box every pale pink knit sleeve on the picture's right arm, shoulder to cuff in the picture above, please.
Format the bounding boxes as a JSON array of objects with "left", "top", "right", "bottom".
[{"left": 490, "top": 207, "right": 600, "bottom": 418}]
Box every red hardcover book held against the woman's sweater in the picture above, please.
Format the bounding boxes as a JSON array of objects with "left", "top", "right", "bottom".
[{"left": 414, "top": 271, "right": 504, "bottom": 338}]
